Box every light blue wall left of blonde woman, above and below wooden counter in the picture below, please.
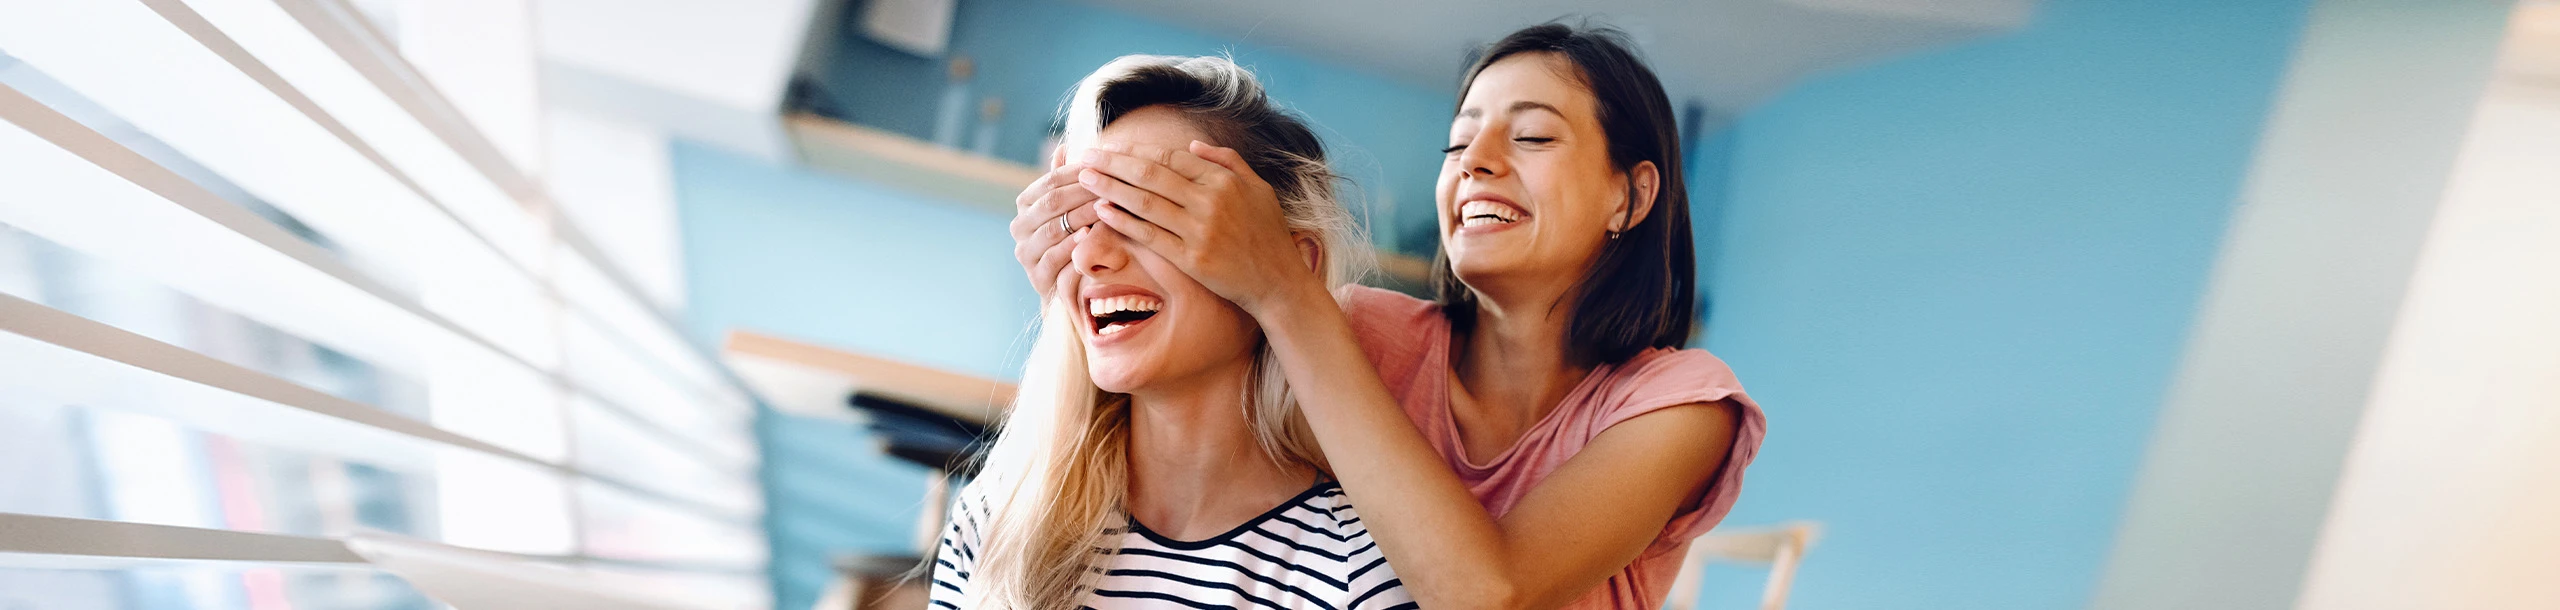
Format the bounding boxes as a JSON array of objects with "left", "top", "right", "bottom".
[{"left": 673, "top": 144, "right": 1037, "bottom": 607}]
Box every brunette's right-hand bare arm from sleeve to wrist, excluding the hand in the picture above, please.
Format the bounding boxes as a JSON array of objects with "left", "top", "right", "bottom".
[{"left": 1262, "top": 283, "right": 1738, "bottom": 607}]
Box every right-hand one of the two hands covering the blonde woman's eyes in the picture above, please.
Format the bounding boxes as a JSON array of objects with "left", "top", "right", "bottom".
[{"left": 1075, "top": 141, "right": 1331, "bottom": 318}]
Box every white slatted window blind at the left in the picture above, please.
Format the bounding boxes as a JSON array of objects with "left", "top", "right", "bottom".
[{"left": 0, "top": 0, "right": 768, "bottom": 607}]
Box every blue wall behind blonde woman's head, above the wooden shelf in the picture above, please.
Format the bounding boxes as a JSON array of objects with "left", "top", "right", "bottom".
[{"left": 822, "top": 0, "right": 1464, "bottom": 254}]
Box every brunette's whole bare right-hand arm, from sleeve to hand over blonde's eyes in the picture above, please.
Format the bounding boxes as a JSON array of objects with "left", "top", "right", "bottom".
[{"left": 1080, "top": 144, "right": 1738, "bottom": 607}]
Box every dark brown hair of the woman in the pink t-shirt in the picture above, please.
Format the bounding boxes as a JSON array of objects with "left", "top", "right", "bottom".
[{"left": 1431, "top": 23, "right": 1697, "bottom": 367}]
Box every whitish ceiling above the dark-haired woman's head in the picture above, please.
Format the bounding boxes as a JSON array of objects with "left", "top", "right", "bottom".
[{"left": 1085, "top": 0, "right": 2035, "bottom": 115}]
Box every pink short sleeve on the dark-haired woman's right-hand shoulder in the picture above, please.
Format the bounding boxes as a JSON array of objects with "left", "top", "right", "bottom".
[{"left": 1592, "top": 349, "right": 1769, "bottom": 554}]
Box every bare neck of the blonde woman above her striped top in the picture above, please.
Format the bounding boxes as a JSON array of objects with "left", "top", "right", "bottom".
[{"left": 1129, "top": 361, "right": 1316, "bottom": 541}]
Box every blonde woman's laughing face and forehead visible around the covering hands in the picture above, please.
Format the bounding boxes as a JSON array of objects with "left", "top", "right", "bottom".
[{"left": 1068, "top": 105, "right": 1262, "bottom": 395}]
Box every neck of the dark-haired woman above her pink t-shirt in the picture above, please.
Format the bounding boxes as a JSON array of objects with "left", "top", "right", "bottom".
[{"left": 1452, "top": 292, "right": 1590, "bottom": 448}]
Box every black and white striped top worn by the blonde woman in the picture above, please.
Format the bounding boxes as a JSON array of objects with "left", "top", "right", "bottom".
[{"left": 932, "top": 482, "right": 1413, "bottom": 610}]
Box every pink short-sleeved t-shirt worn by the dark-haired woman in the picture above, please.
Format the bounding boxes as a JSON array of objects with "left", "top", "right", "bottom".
[{"left": 1341, "top": 287, "right": 1766, "bottom": 610}]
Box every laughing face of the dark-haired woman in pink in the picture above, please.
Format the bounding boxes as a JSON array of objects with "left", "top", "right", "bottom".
[{"left": 1439, "top": 54, "right": 1631, "bottom": 292}]
